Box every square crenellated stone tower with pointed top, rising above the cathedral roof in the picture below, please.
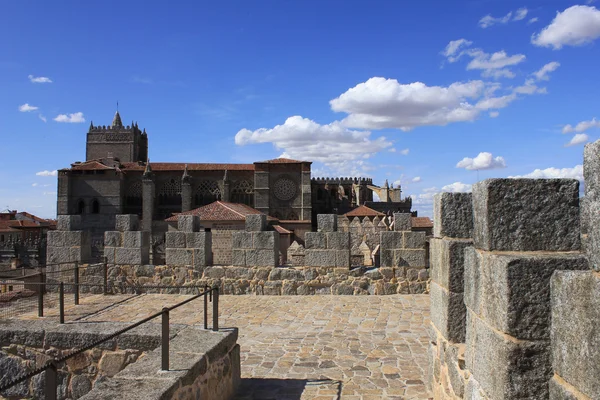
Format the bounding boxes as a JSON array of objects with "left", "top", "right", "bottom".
[{"left": 85, "top": 111, "right": 148, "bottom": 163}]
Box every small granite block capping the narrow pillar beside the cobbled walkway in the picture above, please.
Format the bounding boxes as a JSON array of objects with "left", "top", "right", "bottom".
[{"left": 433, "top": 192, "right": 473, "bottom": 238}]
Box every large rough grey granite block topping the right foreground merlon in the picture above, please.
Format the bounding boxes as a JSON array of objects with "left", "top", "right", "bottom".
[{"left": 473, "top": 179, "right": 581, "bottom": 251}]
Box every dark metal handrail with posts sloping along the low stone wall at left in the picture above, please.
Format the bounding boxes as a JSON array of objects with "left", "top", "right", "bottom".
[{"left": 0, "top": 282, "right": 219, "bottom": 400}]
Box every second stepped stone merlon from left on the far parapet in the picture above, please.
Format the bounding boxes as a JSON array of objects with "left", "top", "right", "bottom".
[{"left": 104, "top": 214, "right": 151, "bottom": 265}]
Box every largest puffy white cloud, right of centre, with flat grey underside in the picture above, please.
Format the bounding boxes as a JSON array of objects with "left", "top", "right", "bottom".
[{"left": 329, "top": 77, "right": 485, "bottom": 131}]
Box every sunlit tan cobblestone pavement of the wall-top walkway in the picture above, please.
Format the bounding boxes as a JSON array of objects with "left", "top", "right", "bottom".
[{"left": 19, "top": 294, "right": 430, "bottom": 400}]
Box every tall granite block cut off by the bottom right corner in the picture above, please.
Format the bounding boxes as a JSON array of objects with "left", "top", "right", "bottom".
[{"left": 551, "top": 271, "right": 600, "bottom": 399}]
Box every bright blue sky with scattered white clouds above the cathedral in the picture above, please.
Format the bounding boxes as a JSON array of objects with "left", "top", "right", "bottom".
[{"left": 0, "top": 0, "right": 600, "bottom": 217}]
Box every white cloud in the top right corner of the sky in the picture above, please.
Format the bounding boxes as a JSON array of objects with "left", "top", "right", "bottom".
[{"left": 531, "top": 6, "right": 600, "bottom": 50}]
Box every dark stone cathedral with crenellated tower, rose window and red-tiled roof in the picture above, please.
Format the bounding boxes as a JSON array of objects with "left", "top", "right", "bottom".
[{"left": 57, "top": 111, "right": 411, "bottom": 237}]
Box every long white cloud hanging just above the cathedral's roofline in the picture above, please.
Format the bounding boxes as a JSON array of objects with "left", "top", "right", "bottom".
[{"left": 235, "top": 116, "right": 392, "bottom": 174}]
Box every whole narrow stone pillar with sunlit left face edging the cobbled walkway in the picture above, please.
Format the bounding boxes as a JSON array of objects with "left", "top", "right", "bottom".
[{"left": 427, "top": 193, "right": 473, "bottom": 399}]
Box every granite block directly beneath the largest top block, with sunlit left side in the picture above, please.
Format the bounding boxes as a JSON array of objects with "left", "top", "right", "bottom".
[{"left": 465, "top": 250, "right": 588, "bottom": 340}]
